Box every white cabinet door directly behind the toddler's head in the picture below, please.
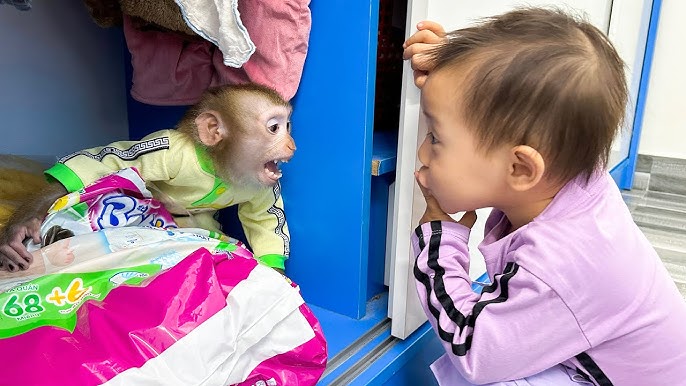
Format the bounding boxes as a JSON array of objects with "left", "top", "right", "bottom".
[{"left": 389, "top": 0, "right": 652, "bottom": 339}]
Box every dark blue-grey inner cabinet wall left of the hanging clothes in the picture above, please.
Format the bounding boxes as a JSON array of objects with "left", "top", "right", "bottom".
[{"left": 0, "top": 0, "right": 128, "bottom": 164}]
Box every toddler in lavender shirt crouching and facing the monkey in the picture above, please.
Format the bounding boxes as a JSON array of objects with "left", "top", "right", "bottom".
[{"left": 404, "top": 8, "right": 686, "bottom": 386}]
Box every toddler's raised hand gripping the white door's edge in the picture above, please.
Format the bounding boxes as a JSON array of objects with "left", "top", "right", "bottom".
[{"left": 403, "top": 21, "right": 445, "bottom": 88}]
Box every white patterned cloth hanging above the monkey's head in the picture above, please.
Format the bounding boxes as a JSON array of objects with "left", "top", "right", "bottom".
[{"left": 175, "top": 0, "right": 255, "bottom": 68}]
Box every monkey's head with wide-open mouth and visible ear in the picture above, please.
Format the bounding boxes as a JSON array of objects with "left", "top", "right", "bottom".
[{"left": 196, "top": 85, "right": 295, "bottom": 187}]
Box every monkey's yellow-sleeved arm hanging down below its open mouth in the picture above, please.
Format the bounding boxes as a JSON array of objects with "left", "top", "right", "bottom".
[{"left": 238, "top": 184, "right": 291, "bottom": 270}]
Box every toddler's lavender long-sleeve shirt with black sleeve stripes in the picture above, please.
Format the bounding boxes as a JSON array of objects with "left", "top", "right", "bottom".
[{"left": 412, "top": 174, "right": 686, "bottom": 386}]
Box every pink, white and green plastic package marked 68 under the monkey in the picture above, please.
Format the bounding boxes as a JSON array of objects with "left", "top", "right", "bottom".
[{"left": 0, "top": 171, "right": 327, "bottom": 386}]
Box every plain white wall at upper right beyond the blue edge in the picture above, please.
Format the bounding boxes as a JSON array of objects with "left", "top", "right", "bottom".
[{"left": 638, "top": 0, "right": 686, "bottom": 159}]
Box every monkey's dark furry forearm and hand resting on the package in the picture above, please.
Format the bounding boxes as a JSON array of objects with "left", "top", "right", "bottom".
[{"left": 0, "top": 184, "right": 67, "bottom": 272}]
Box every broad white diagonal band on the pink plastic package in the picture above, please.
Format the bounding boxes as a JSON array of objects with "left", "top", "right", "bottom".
[{"left": 103, "top": 264, "right": 314, "bottom": 386}]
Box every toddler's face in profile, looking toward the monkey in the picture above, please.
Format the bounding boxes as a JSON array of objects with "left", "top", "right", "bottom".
[{"left": 417, "top": 71, "right": 507, "bottom": 213}]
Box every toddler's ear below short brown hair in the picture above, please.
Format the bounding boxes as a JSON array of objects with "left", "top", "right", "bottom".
[{"left": 507, "top": 145, "right": 545, "bottom": 192}]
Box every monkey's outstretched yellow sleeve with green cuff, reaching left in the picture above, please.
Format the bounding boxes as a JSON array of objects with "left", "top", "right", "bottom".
[{"left": 45, "top": 130, "right": 185, "bottom": 192}]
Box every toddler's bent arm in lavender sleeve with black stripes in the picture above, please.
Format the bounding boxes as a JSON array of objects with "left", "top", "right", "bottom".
[{"left": 412, "top": 221, "right": 590, "bottom": 384}]
